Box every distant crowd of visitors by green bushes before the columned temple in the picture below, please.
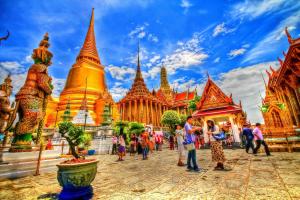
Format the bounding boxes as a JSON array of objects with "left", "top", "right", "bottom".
[{"left": 112, "top": 130, "right": 163, "bottom": 161}]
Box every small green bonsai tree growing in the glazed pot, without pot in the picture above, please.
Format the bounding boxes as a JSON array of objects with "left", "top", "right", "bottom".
[{"left": 58, "top": 121, "right": 87, "bottom": 159}]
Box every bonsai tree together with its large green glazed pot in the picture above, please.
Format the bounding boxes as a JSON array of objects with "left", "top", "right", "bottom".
[{"left": 57, "top": 121, "right": 99, "bottom": 199}]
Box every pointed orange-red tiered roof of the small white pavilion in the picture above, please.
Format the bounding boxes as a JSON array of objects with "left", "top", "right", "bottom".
[{"left": 193, "top": 77, "right": 242, "bottom": 117}]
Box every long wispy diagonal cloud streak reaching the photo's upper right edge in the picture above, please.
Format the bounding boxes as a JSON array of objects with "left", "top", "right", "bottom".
[{"left": 243, "top": 13, "right": 300, "bottom": 63}]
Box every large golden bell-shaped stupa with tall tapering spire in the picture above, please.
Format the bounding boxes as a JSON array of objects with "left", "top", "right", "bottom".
[{"left": 47, "top": 9, "right": 115, "bottom": 127}]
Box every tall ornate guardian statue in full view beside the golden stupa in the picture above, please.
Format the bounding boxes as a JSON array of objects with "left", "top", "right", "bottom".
[{"left": 10, "top": 33, "right": 53, "bottom": 151}]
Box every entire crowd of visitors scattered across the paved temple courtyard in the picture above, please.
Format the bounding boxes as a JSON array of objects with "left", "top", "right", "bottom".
[{"left": 112, "top": 116, "right": 271, "bottom": 172}]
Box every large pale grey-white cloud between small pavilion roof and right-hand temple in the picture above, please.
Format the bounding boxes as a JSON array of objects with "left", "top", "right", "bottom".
[{"left": 217, "top": 61, "right": 279, "bottom": 123}]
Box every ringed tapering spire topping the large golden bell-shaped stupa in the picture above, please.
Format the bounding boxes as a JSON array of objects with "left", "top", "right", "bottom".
[{"left": 77, "top": 8, "right": 100, "bottom": 63}]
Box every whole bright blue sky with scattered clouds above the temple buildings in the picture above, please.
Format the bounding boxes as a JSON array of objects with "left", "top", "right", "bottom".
[{"left": 0, "top": 0, "right": 300, "bottom": 122}]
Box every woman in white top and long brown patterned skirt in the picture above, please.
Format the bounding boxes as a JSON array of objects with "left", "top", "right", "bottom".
[{"left": 206, "top": 120, "right": 225, "bottom": 170}]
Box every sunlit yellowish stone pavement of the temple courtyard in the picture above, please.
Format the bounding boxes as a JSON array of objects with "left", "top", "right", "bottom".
[{"left": 0, "top": 149, "right": 300, "bottom": 200}]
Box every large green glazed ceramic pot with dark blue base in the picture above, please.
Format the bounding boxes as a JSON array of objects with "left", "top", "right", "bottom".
[{"left": 57, "top": 159, "right": 99, "bottom": 199}]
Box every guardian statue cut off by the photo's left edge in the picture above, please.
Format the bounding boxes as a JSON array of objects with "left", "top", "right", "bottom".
[{"left": 0, "top": 75, "right": 14, "bottom": 145}]
